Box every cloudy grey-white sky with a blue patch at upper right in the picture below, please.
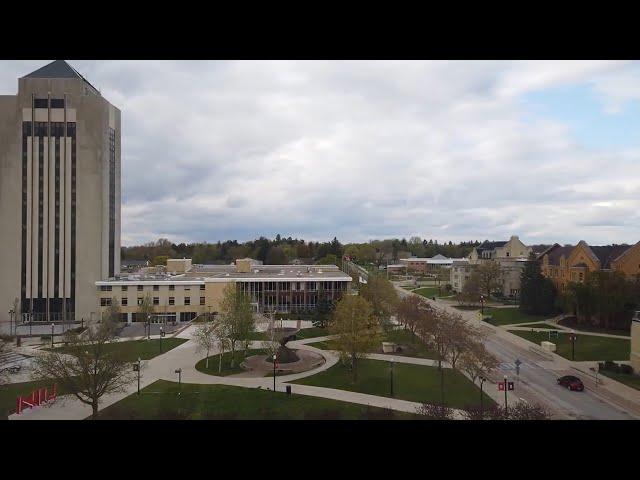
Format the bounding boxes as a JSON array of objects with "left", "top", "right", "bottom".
[{"left": 0, "top": 60, "right": 640, "bottom": 245}]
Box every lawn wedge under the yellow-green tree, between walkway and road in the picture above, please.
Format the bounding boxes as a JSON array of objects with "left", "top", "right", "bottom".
[{"left": 291, "top": 359, "right": 494, "bottom": 408}]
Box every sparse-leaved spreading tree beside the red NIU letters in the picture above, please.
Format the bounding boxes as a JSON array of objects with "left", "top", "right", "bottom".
[{"left": 32, "top": 321, "right": 136, "bottom": 419}]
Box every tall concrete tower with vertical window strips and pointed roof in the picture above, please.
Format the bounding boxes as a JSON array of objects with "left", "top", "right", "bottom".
[{"left": 0, "top": 60, "right": 120, "bottom": 322}]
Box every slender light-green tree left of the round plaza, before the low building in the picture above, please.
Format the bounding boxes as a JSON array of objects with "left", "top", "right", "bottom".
[{"left": 220, "top": 284, "right": 255, "bottom": 368}]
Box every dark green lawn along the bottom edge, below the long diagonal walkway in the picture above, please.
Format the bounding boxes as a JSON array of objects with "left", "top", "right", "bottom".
[{"left": 99, "top": 380, "right": 420, "bottom": 420}]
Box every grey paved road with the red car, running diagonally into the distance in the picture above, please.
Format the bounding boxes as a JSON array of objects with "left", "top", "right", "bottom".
[{"left": 396, "top": 287, "right": 637, "bottom": 420}]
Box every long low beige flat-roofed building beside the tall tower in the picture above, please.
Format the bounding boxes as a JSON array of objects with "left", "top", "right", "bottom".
[{"left": 94, "top": 258, "right": 352, "bottom": 322}]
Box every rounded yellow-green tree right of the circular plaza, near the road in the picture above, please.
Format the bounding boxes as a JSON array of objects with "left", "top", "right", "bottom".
[{"left": 329, "top": 295, "right": 380, "bottom": 382}]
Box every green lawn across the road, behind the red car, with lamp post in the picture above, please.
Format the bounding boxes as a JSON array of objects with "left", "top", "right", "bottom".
[{"left": 511, "top": 330, "right": 631, "bottom": 362}]
